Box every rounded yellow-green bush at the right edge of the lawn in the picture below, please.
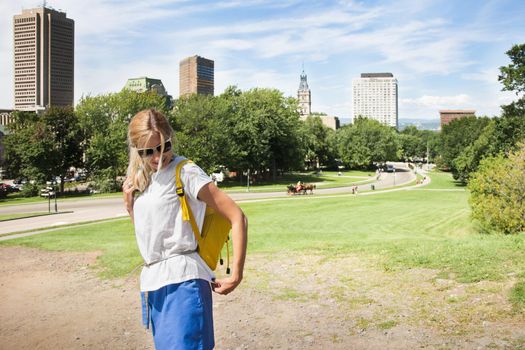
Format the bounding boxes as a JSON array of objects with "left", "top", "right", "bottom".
[{"left": 469, "top": 143, "right": 525, "bottom": 234}]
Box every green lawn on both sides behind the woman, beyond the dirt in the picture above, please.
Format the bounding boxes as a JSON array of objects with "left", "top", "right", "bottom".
[{"left": 1, "top": 173, "right": 525, "bottom": 306}]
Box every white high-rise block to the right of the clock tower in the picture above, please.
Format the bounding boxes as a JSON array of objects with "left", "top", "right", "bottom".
[{"left": 352, "top": 73, "right": 398, "bottom": 128}]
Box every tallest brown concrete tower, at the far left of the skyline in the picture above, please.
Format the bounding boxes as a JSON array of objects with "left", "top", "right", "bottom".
[{"left": 13, "top": 7, "right": 75, "bottom": 111}]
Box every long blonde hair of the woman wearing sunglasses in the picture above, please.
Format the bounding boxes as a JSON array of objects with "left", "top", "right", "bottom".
[{"left": 127, "top": 109, "right": 173, "bottom": 192}]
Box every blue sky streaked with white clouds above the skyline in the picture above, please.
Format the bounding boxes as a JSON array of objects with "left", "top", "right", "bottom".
[{"left": 0, "top": 0, "right": 525, "bottom": 119}]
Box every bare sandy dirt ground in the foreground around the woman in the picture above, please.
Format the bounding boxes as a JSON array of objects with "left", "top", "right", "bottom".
[{"left": 0, "top": 247, "right": 525, "bottom": 349}]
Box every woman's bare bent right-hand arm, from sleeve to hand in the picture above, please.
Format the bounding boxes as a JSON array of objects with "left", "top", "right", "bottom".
[{"left": 198, "top": 182, "right": 248, "bottom": 294}]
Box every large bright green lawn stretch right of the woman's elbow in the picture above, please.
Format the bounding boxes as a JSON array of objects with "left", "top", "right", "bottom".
[{"left": 243, "top": 174, "right": 525, "bottom": 282}]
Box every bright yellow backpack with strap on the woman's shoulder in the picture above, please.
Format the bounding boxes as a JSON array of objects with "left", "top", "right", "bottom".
[{"left": 175, "top": 159, "right": 232, "bottom": 274}]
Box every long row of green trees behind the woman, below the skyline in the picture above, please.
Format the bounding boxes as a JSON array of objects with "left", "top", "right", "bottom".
[{"left": 5, "top": 87, "right": 438, "bottom": 190}]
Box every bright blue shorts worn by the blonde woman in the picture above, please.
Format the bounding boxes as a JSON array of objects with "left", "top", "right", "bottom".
[{"left": 141, "top": 279, "right": 215, "bottom": 350}]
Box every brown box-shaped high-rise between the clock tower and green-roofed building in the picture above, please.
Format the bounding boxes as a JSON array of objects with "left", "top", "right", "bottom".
[{"left": 179, "top": 56, "right": 214, "bottom": 96}]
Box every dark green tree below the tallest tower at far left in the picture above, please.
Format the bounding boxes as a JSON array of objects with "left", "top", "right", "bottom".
[{"left": 5, "top": 107, "right": 82, "bottom": 191}]
